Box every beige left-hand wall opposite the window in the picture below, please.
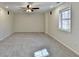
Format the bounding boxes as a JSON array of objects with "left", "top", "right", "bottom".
[{"left": 0, "top": 8, "right": 13, "bottom": 40}]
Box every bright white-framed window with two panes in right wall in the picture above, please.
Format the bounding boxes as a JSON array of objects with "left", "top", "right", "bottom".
[{"left": 59, "top": 8, "right": 71, "bottom": 32}]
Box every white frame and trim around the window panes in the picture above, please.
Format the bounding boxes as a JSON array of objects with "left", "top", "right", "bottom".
[{"left": 58, "top": 7, "right": 72, "bottom": 32}]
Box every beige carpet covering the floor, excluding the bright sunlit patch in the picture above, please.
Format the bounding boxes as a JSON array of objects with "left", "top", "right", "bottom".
[{"left": 0, "top": 33, "right": 77, "bottom": 57}]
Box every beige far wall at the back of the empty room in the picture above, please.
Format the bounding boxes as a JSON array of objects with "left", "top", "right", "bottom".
[{"left": 14, "top": 14, "right": 45, "bottom": 32}]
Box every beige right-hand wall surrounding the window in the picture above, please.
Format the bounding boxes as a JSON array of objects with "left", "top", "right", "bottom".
[{"left": 45, "top": 2, "right": 79, "bottom": 54}]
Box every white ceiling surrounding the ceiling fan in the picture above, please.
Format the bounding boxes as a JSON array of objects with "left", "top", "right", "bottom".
[{"left": 0, "top": 2, "right": 62, "bottom": 12}]
